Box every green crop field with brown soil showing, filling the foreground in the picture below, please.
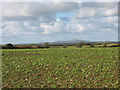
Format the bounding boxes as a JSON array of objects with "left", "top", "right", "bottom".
[{"left": 2, "top": 47, "right": 119, "bottom": 88}]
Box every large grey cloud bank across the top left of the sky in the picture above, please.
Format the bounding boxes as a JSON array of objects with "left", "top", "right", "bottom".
[{"left": 3, "top": 2, "right": 79, "bottom": 22}]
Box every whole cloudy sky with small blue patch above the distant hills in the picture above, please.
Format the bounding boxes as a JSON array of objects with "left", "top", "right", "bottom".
[{"left": 0, "top": 2, "right": 118, "bottom": 44}]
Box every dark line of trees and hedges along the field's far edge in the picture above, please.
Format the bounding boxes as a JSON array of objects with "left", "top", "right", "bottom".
[{"left": 1, "top": 42, "right": 120, "bottom": 49}]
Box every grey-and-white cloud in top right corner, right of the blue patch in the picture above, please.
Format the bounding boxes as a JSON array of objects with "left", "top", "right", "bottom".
[{"left": 75, "top": 2, "right": 118, "bottom": 19}]
